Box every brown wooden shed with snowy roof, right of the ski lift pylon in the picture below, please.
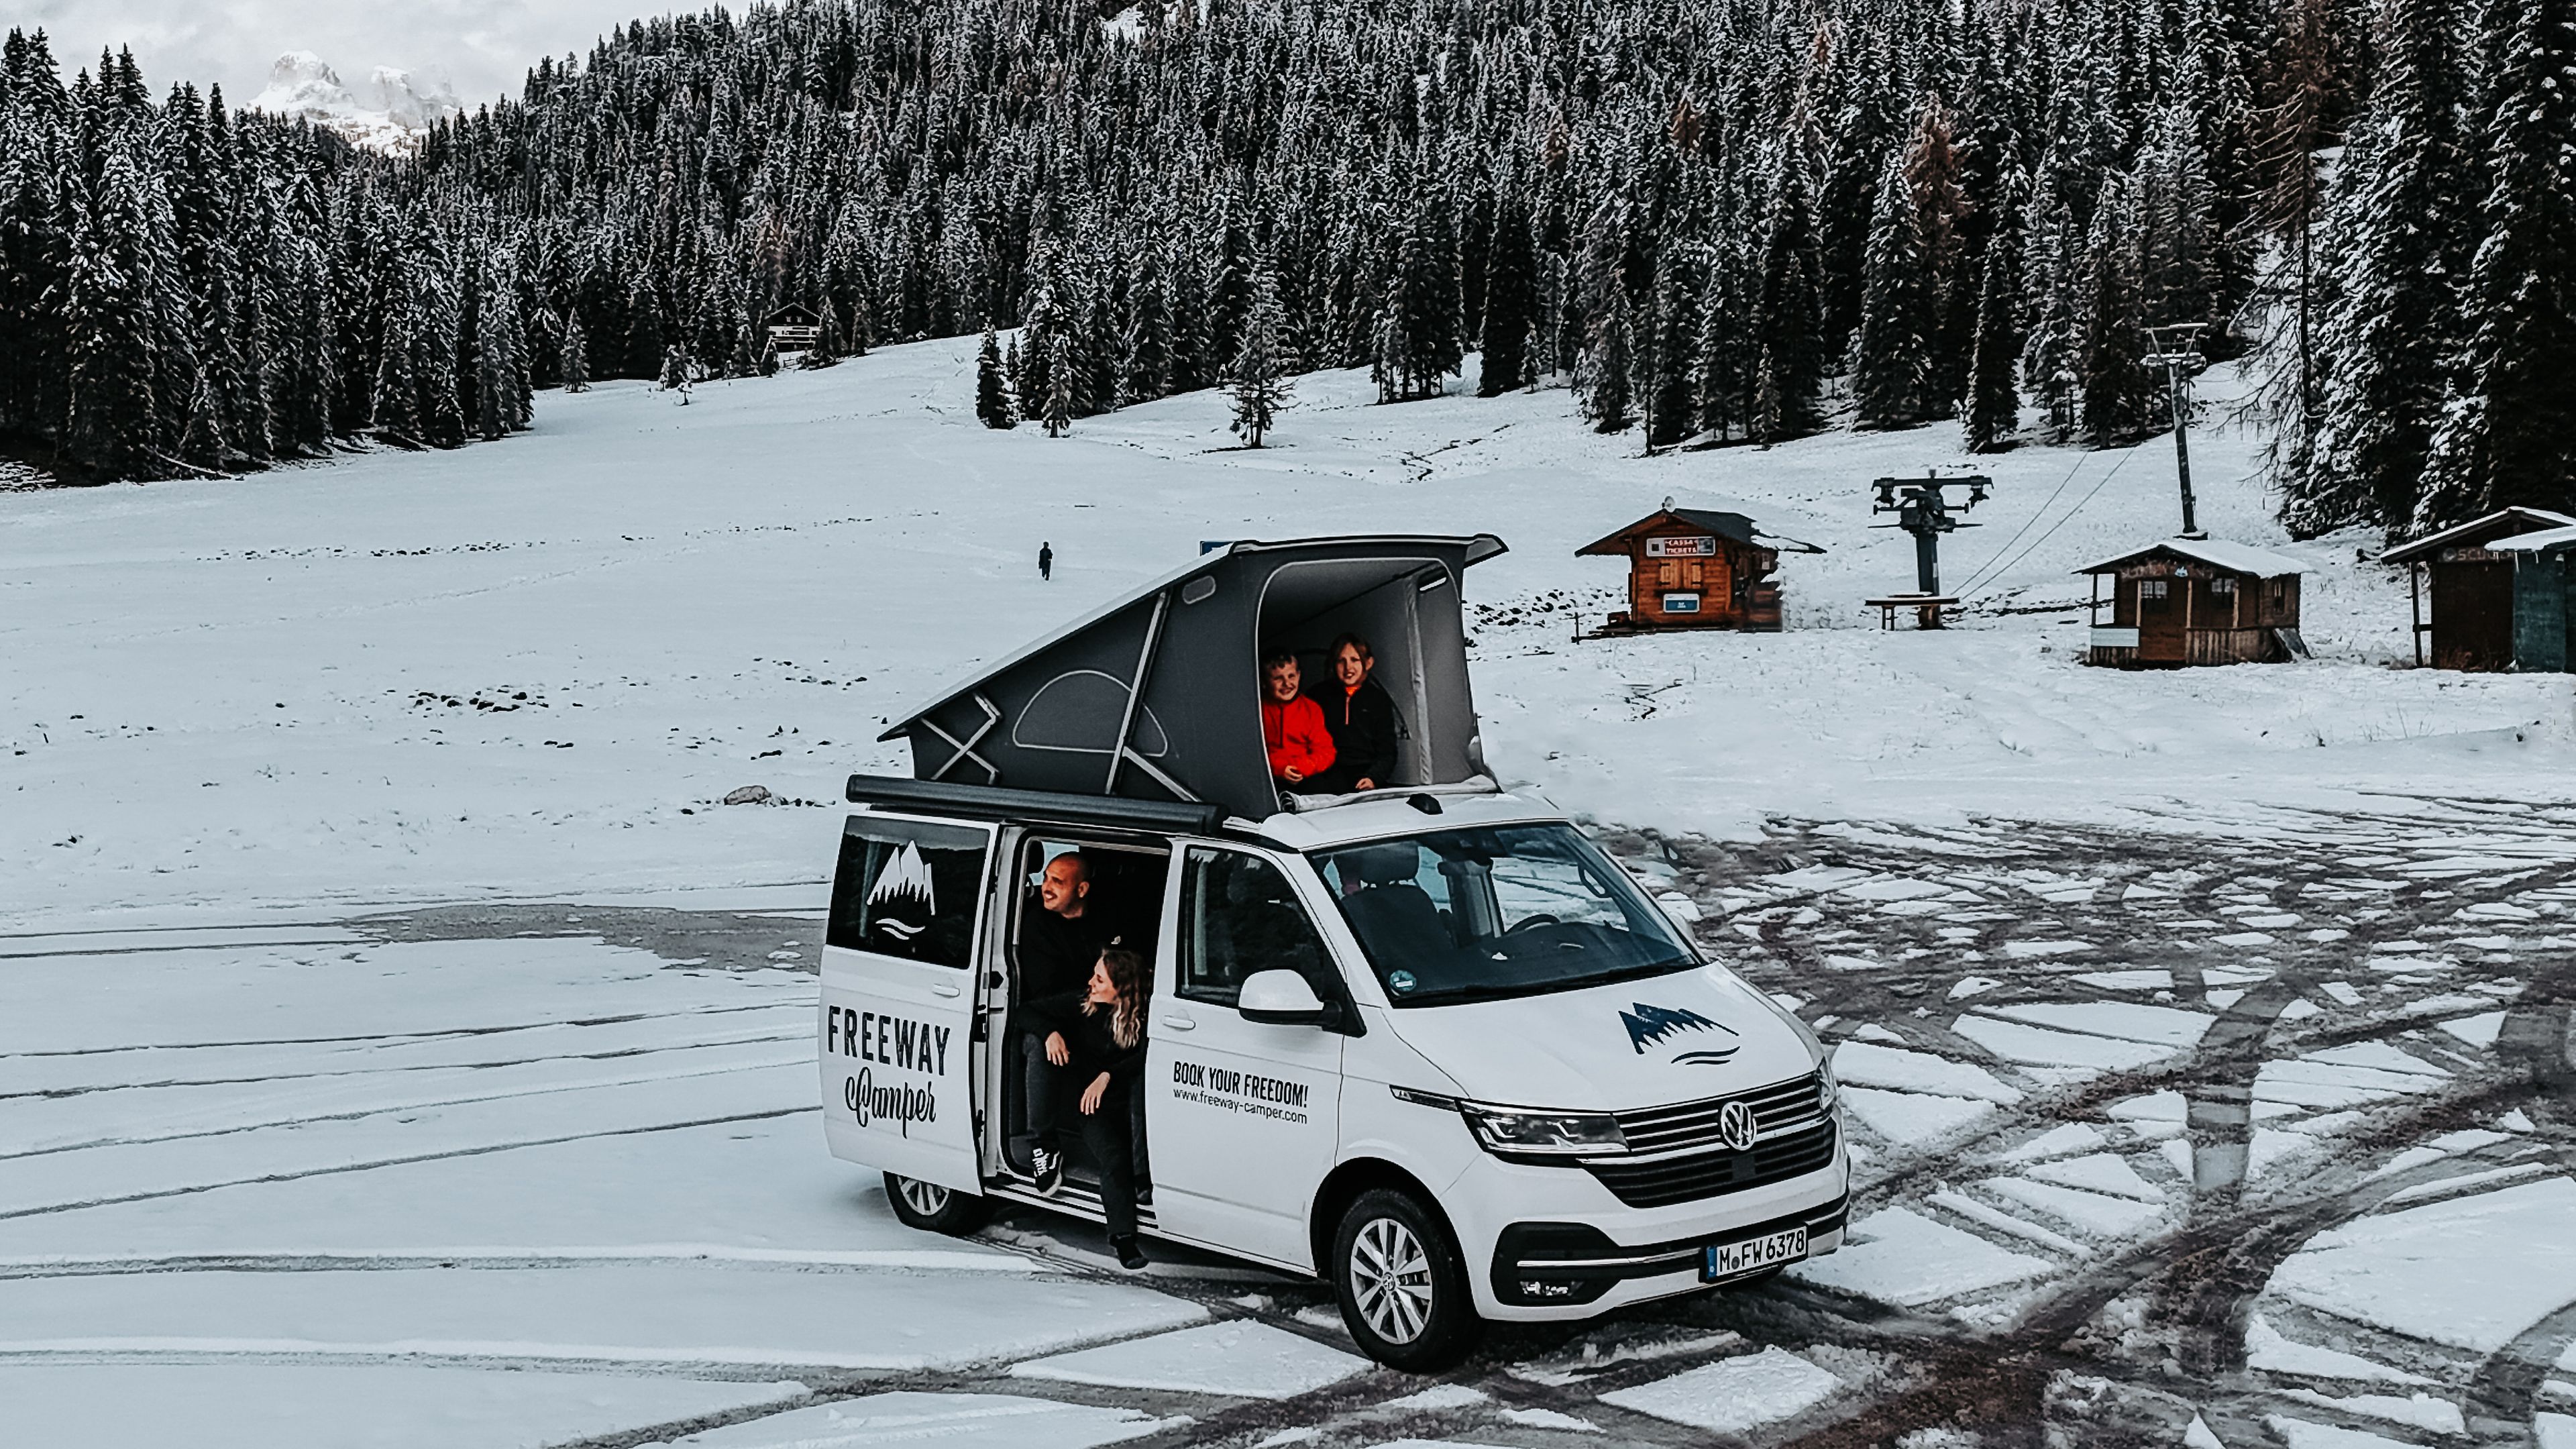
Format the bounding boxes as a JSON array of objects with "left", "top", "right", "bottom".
[{"left": 2076, "top": 539, "right": 2308, "bottom": 667}]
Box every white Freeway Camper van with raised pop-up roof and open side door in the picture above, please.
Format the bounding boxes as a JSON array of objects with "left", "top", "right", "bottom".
[{"left": 816, "top": 539, "right": 1849, "bottom": 1369}]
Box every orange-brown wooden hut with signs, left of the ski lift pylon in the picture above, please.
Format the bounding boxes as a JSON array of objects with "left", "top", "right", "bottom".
[{"left": 1574, "top": 498, "right": 1824, "bottom": 634}]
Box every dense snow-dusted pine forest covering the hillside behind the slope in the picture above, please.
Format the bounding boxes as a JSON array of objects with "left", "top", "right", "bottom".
[{"left": 0, "top": 0, "right": 2576, "bottom": 534}]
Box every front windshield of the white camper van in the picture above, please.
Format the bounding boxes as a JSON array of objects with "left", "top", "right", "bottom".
[{"left": 1313, "top": 825, "right": 1698, "bottom": 1006}]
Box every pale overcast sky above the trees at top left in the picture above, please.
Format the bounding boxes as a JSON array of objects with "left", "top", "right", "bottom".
[{"left": 22, "top": 0, "right": 644, "bottom": 106}]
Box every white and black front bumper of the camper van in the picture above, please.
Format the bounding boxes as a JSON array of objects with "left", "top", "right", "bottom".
[{"left": 1442, "top": 1129, "right": 1852, "bottom": 1323}]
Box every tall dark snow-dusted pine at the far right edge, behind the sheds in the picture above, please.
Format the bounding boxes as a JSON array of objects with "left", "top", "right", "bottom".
[{"left": 2414, "top": 0, "right": 2576, "bottom": 529}]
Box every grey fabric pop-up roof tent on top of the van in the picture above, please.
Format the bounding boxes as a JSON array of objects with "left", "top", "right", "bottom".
[{"left": 878, "top": 534, "right": 1505, "bottom": 820}]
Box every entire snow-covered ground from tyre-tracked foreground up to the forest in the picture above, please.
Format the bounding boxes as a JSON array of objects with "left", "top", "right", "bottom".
[{"left": 0, "top": 343, "right": 2576, "bottom": 1449}]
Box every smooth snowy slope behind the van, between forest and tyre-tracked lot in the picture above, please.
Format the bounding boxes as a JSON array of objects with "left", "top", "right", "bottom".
[{"left": 0, "top": 340, "right": 2576, "bottom": 926}]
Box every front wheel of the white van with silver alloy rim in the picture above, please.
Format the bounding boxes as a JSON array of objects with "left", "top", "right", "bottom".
[{"left": 1332, "top": 1189, "right": 1484, "bottom": 1375}]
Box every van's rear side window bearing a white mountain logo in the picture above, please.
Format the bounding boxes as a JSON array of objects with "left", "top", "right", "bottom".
[{"left": 822, "top": 815, "right": 991, "bottom": 967}]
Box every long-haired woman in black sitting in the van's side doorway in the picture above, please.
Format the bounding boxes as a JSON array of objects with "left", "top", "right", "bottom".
[{"left": 1020, "top": 947, "right": 1151, "bottom": 1269}]
